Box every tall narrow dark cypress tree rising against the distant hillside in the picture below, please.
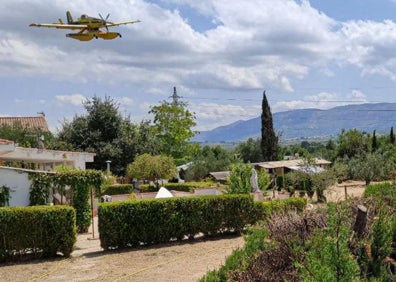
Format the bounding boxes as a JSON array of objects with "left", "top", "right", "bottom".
[{"left": 261, "top": 91, "right": 279, "bottom": 162}]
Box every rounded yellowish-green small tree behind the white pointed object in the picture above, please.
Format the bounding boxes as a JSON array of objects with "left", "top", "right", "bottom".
[{"left": 127, "top": 154, "right": 177, "bottom": 181}]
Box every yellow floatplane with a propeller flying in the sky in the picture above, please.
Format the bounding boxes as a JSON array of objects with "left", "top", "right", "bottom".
[{"left": 29, "top": 11, "right": 140, "bottom": 41}]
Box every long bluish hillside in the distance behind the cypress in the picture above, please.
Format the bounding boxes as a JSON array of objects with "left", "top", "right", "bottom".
[{"left": 193, "top": 103, "right": 396, "bottom": 142}]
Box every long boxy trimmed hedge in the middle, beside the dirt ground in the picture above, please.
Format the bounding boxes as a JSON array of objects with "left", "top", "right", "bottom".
[{"left": 98, "top": 195, "right": 256, "bottom": 249}]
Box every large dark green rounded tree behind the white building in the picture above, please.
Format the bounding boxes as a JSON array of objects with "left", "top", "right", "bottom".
[{"left": 58, "top": 96, "right": 145, "bottom": 175}]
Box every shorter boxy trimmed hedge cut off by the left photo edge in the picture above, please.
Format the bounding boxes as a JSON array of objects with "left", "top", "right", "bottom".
[{"left": 0, "top": 206, "right": 76, "bottom": 262}]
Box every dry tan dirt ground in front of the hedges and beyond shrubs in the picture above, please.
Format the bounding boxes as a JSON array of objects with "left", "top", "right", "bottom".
[{"left": 0, "top": 182, "right": 364, "bottom": 282}]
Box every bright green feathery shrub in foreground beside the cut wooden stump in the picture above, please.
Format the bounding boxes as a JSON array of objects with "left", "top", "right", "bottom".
[{"left": 297, "top": 205, "right": 360, "bottom": 282}]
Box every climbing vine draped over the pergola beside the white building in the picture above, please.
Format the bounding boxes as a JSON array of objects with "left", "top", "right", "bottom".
[{"left": 29, "top": 170, "right": 102, "bottom": 233}]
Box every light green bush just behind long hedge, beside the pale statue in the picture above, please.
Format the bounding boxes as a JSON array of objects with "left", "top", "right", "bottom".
[{"left": 225, "top": 164, "right": 252, "bottom": 194}]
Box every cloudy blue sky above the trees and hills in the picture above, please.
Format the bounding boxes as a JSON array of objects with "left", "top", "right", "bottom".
[{"left": 0, "top": 0, "right": 396, "bottom": 132}]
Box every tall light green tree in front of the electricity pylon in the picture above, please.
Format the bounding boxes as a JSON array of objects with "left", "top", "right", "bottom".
[{"left": 149, "top": 87, "right": 196, "bottom": 159}]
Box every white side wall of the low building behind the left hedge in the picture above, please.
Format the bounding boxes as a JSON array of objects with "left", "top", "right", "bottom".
[{"left": 0, "top": 167, "right": 30, "bottom": 206}]
